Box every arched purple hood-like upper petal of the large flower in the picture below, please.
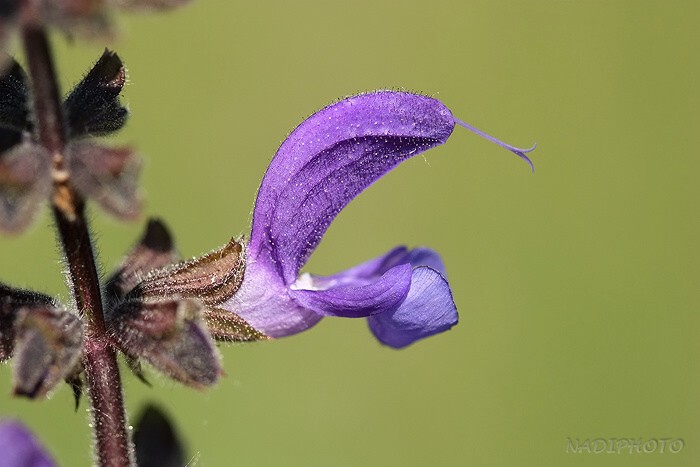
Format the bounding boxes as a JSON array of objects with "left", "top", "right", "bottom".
[{"left": 249, "top": 91, "right": 455, "bottom": 284}]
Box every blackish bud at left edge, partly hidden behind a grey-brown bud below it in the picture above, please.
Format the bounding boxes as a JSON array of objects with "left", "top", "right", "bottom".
[{"left": 0, "top": 283, "right": 54, "bottom": 362}]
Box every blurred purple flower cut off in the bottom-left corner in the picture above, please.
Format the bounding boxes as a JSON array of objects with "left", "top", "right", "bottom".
[{"left": 0, "top": 421, "right": 55, "bottom": 467}]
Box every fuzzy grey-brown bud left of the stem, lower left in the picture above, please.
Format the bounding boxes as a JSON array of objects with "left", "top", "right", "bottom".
[{"left": 13, "top": 305, "right": 83, "bottom": 399}]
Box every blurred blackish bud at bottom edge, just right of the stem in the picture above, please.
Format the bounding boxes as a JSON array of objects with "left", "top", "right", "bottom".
[{"left": 134, "top": 404, "right": 187, "bottom": 467}]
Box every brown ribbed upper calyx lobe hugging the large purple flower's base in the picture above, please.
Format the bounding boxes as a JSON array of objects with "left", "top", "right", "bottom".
[{"left": 130, "top": 239, "right": 245, "bottom": 306}]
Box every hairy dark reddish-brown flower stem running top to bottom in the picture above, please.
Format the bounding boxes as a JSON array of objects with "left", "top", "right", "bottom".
[{"left": 22, "top": 21, "right": 134, "bottom": 467}]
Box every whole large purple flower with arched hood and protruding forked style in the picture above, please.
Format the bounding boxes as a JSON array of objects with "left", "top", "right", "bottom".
[{"left": 221, "top": 91, "right": 534, "bottom": 348}]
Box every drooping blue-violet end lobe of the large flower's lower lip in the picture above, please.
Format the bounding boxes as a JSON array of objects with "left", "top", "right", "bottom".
[{"left": 368, "top": 267, "right": 458, "bottom": 349}]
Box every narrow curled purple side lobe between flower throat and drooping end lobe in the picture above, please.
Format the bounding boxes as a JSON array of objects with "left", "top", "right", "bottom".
[{"left": 289, "top": 264, "right": 411, "bottom": 318}]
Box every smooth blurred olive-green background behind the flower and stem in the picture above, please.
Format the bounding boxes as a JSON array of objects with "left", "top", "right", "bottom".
[{"left": 0, "top": 0, "right": 700, "bottom": 467}]
